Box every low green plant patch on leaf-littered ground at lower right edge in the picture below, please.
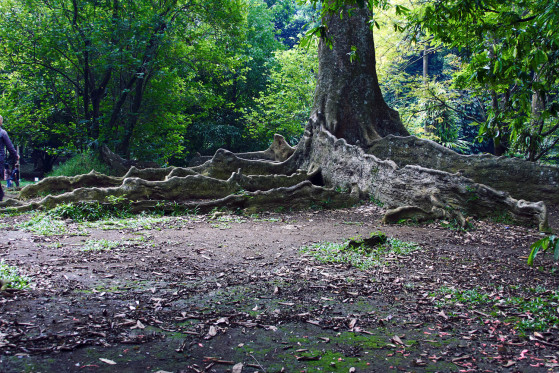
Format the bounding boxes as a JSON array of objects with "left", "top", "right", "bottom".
[{"left": 431, "top": 287, "right": 558, "bottom": 334}]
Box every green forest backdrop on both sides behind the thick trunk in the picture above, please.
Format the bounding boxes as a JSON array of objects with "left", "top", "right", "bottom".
[{"left": 0, "top": 0, "right": 558, "bottom": 172}]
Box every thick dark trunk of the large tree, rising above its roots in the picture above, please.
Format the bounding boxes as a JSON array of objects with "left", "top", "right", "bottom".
[{"left": 311, "top": 7, "right": 408, "bottom": 148}]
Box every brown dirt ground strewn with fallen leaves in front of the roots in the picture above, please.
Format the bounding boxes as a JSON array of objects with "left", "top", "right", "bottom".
[{"left": 0, "top": 196, "right": 558, "bottom": 373}]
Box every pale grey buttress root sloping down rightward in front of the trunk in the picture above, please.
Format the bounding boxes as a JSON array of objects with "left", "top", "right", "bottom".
[{"left": 301, "top": 117, "right": 548, "bottom": 229}]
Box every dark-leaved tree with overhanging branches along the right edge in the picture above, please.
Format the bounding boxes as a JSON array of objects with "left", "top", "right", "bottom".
[{"left": 410, "top": 0, "right": 558, "bottom": 161}]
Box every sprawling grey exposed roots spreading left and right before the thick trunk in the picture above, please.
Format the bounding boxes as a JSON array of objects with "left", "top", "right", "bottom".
[{"left": 8, "top": 128, "right": 547, "bottom": 229}]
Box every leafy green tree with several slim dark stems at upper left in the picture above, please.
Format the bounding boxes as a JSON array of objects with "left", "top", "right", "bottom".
[{"left": 0, "top": 0, "right": 245, "bottom": 169}]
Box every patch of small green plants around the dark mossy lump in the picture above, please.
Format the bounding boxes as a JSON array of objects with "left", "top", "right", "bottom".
[{"left": 301, "top": 233, "right": 420, "bottom": 270}]
